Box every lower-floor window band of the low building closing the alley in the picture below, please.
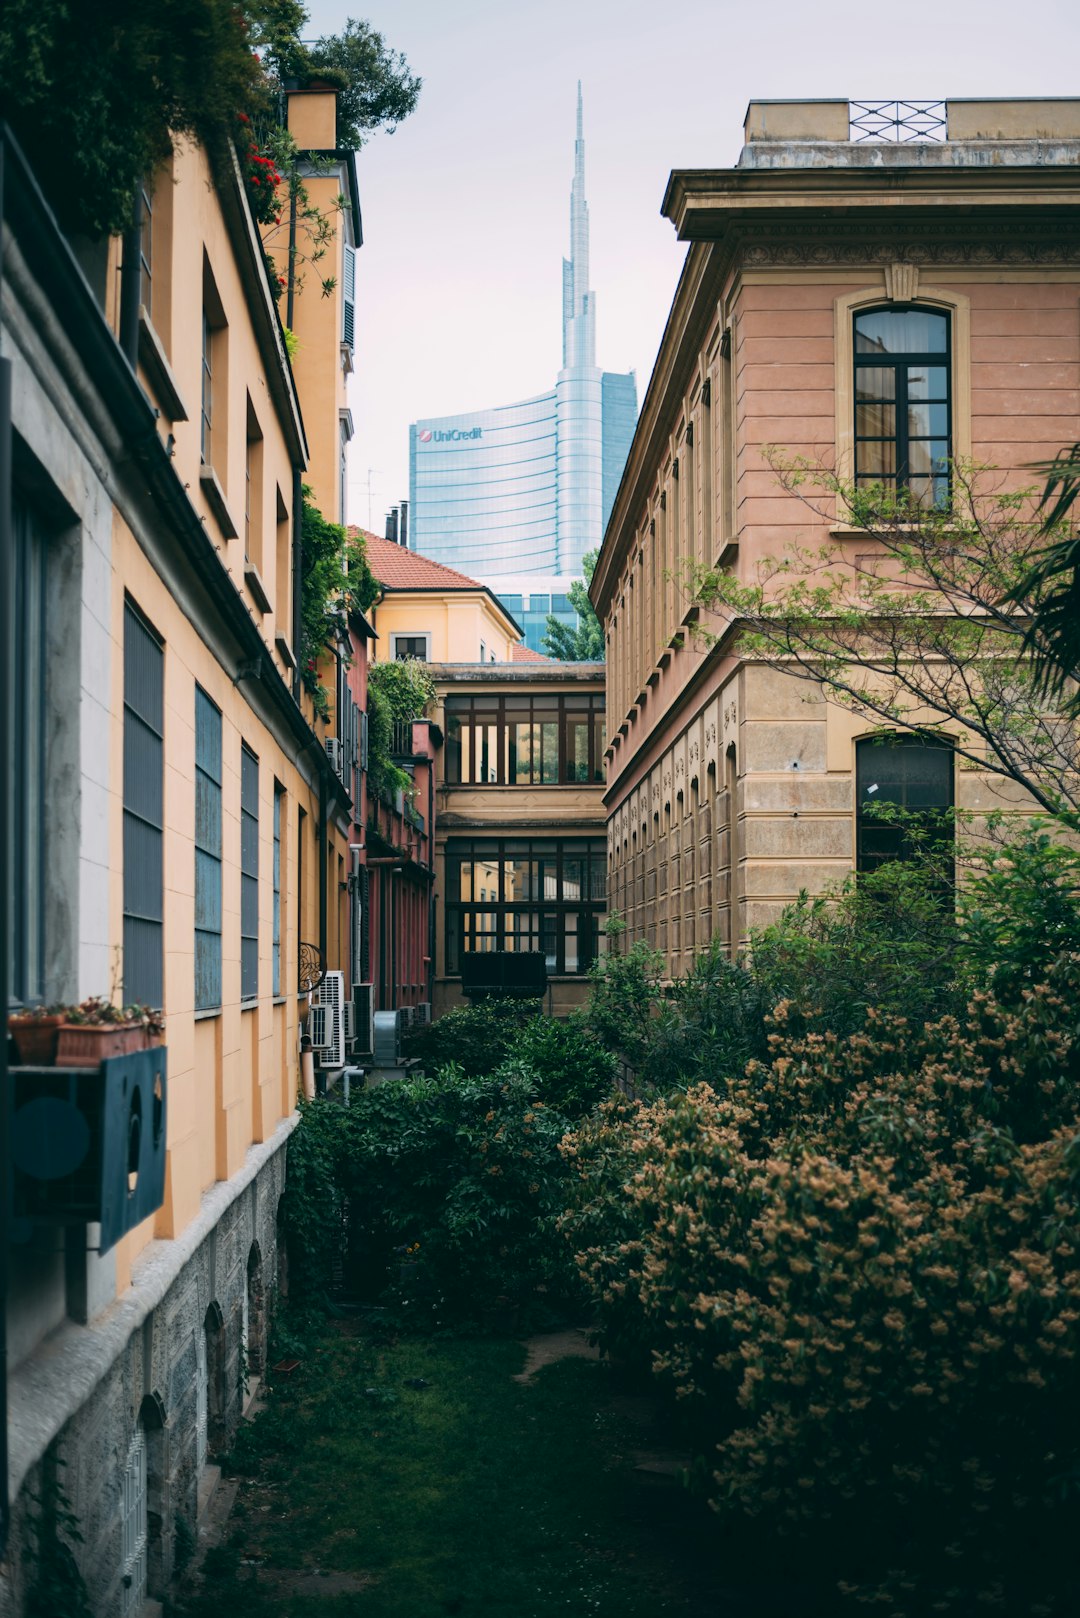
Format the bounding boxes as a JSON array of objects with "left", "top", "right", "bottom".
[{"left": 447, "top": 838, "right": 607, "bottom": 976}]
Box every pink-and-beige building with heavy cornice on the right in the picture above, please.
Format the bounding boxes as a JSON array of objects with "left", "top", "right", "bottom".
[{"left": 591, "top": 102, "right": 1080, "bottom": 976}]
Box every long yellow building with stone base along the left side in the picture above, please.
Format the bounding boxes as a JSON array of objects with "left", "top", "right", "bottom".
[{"left": 0, "top": 95, "right": 356, "bottom": 1618}]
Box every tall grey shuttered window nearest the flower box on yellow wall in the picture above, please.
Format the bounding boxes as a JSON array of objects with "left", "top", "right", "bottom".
[{"left": 123, "top": 602, "right": 165, "bottom": 1006}]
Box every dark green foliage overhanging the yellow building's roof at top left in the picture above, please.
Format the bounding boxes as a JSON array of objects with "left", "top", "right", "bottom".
[{"left": 0, "top": 0, "right": 419, "bottom": 236}]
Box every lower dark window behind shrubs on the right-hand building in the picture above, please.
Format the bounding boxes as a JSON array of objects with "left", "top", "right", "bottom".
[{"left": 855, "top": 735, "right": 955, "bottom": 870}]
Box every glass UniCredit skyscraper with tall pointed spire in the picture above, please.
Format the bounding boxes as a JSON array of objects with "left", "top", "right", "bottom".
[{"left": 410, "top": 84, "right": 638, "bottom": 649}]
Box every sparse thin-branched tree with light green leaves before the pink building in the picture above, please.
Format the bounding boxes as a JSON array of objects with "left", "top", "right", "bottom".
[{"left": 687, "top": 451, "right": 1080, "bottom": 827}]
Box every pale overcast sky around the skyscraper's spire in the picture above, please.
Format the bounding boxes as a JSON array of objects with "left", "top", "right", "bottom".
[{"left": 304, "top": 0, "right": 1080, "bottom": 532}]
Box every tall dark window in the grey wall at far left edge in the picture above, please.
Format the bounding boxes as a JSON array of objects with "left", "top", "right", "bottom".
[{"left": 5, "top": 498, "right": 49, "bottom": 1003}]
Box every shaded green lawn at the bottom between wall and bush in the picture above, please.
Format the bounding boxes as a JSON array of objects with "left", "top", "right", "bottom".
[{"left": 189, "top": 1328, "right": 735, "bottom": 1618}]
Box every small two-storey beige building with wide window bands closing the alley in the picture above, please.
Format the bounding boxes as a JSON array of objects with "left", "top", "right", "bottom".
[{"left": 431, "top": 660, "right": 607, "bottom": 1016}]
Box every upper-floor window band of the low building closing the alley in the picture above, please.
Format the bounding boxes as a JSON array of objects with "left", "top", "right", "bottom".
[{"left": 445, "top": 693, "right": 606, "bottom": 786}]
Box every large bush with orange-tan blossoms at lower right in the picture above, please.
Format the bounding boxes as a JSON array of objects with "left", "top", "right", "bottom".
[{"left": 562, "top": 955, "right": 1080, "bottom": 1615}]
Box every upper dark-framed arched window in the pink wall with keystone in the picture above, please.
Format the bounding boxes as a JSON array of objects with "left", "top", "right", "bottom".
[{"left": 855, "top": 306, "right": 952, "bottom": 511}]
